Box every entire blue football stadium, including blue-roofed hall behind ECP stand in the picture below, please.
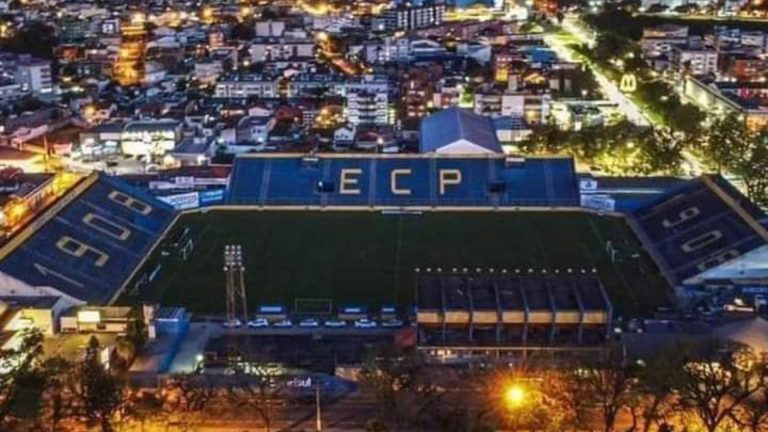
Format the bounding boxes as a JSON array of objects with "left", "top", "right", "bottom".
[{"left": 0, "top": 110, "right": 768, "bottom": 354}]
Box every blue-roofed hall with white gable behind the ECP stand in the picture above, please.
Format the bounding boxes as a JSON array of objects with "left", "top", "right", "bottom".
[{"left": 420, "top": 107, "right": 503, "bottom": 154}]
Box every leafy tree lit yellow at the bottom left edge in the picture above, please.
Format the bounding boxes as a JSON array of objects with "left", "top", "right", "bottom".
[{"left": 0, "top": 329, "right": 43, "bottom": 424}]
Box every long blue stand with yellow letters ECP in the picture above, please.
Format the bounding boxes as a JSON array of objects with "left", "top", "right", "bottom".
[{"left": 227, "top": 154, "right": 579, "bottom": 207}]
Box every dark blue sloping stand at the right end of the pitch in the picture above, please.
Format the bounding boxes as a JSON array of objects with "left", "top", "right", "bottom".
[{"left": 628, "top": 176, "right": 768, "bottom": 286}]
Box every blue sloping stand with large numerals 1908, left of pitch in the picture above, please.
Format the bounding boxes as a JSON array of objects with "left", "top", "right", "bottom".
[{"left": 0, "top": 174, "right": 175, "bottom": 304}]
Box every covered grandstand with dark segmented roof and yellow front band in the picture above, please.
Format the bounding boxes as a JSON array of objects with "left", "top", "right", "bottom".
[{"left": 416, "top": 271, "right": 613, "bottom": 357}]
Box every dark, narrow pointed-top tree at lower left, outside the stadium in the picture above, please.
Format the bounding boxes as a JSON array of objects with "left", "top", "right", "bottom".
[{"left": 77, "top": 337, "right": 123, "bottom": 432}]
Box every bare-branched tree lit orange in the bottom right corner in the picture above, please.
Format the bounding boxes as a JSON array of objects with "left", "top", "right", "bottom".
[{"left": 678, "top": 341, "right": 766, "bottom": 432}]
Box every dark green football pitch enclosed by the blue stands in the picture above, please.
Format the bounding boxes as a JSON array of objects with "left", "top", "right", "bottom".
[{"left": 139, "top": 210, "right": 669, "bottom": 316}]
